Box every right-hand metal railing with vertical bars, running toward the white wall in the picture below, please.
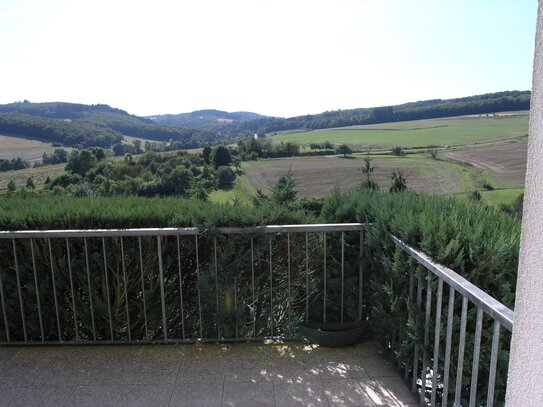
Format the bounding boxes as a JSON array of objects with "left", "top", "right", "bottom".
[{"left": 391, "top": 235, "right": 514, "bottom": 407}]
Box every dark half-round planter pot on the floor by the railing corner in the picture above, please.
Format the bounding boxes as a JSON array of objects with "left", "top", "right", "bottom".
[{"left": 300, "top": 321, "right": 369, "bottom": 348}]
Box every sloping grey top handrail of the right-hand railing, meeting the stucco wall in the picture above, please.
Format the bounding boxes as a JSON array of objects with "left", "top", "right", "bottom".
[{"left": 390, "top": 234, "right": 515, "bottom": 332}]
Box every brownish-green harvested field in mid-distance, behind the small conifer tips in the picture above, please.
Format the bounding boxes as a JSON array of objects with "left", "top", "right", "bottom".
[{"left": 243, "top": 155, "right": 464, "bottom": 198}]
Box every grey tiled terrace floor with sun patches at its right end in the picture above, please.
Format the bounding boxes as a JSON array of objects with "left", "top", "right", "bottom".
[{"left": 0, "top": 341, "right": 417, "bottom": 407}]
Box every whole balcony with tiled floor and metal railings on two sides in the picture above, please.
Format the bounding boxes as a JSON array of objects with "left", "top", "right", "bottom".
[{"left": 0, "top": 224, "right": 513, "bottom": 406}]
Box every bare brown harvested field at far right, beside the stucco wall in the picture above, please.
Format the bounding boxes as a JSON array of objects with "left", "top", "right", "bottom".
[{"left": 444, "top": 143, "right": 528, "bottom": 188}]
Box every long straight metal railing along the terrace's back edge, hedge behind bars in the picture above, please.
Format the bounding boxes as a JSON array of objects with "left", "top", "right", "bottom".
[{"left": 0, "top": 223, "right": 364, "bottom": 344}]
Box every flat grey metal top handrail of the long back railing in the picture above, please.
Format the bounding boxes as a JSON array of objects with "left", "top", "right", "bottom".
[{"left": 0, "top": 223, "right": 365, "bottom": 239}]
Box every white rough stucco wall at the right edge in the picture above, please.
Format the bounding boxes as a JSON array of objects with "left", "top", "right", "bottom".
[{"left": 506, "top": 0, "right": 543, "bottom": 407}]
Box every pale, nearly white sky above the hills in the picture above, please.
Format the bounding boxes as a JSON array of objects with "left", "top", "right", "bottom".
[{"left": 0, "top": 0, "right": 537, "bottom": 117}]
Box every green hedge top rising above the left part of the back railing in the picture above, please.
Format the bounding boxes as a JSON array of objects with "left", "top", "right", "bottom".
[{"left": 0, "top": 193, "right": 312, "bottom": 230}]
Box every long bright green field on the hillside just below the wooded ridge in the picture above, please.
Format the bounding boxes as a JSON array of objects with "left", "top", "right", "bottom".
[{"left": 270, "top": 112, "right": 529, "bottom": 148}]
